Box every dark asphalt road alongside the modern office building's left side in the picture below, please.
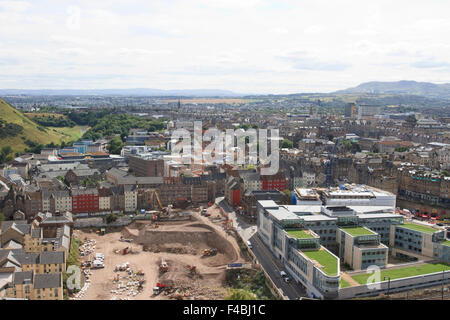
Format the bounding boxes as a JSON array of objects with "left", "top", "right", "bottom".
[{"left": 250, "top": 234, "right": 308, "bottom": 300}]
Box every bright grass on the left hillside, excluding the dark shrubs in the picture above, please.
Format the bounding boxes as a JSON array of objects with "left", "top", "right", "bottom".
[{"left": 0, "top": 99, "right": 82, "bottom": 152}]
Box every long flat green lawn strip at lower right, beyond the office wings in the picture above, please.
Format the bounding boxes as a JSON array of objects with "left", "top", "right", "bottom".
[{"left": 352, "top": 263, "right": 450, "bottom": 284}]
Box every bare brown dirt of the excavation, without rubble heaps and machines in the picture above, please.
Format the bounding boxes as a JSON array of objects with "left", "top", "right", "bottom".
[{"left": 75, "top": 213, "right": 245, "bottom": 300}]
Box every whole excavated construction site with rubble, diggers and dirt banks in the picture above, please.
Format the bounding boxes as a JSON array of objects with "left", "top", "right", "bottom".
[{"left": 74, "top": 205, "right": 251, "bottom": 300}]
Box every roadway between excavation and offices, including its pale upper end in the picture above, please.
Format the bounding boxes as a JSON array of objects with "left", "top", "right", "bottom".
[{"left": 215, "top": 197, "right": 308, "bottom": 300}]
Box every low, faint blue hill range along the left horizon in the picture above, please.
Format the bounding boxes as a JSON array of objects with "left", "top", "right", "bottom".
[{"left": 0, "top": 88, "right": 241, "bottom": 97}]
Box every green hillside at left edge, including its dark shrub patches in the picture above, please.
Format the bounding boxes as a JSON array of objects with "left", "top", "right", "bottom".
[{"left": 0, "top": 99, "right": 83, "bottom": 156}]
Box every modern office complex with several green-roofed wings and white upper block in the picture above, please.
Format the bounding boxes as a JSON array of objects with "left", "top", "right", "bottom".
[{"left": 257, "top": 188, "right": 450, "bottom": 299}]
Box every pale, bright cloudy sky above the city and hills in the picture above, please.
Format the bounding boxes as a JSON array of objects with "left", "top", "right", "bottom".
[{"left": 0, "top": 0, "right": 450, "bottom": 94}]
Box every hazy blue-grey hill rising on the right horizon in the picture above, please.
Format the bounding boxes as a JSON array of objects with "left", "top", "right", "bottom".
[{"left": 334, "top": 80, "right": 450, "bottom": 98}]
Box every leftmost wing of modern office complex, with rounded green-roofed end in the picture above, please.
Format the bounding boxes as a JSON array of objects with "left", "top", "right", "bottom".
[{"left": 257, "top": 200, "right": 340, "bottom": 299}]
